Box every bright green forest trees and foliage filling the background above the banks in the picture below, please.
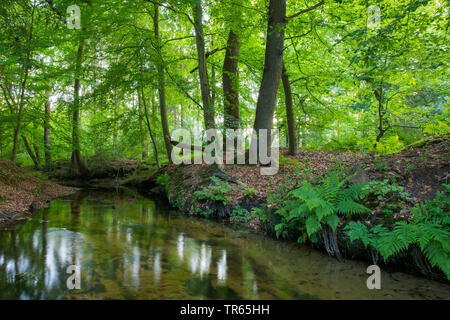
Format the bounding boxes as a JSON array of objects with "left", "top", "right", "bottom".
[{"left": 0, "top": 0, "right": 450, "bottom": 173}]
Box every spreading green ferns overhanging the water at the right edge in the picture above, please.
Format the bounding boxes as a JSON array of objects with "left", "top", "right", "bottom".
[{"left": 345, "top": 185, "right": 450, "bottom": 278}]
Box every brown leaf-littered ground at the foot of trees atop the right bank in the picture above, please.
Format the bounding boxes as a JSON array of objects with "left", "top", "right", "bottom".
[{"left": 147, "top": 135, "right": 450, "bottom": 226}]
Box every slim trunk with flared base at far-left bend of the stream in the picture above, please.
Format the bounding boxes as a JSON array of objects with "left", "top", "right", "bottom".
[{"left": 72, "top": 39, "right": 88, "bottom": 176}]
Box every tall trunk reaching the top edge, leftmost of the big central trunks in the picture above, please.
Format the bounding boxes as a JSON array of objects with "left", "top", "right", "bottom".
[{"left": 194, "top": 0, "right": 215, "bottom": 129}]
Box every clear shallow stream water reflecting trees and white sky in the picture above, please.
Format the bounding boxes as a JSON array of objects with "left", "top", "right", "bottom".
[{"left": 0, "top": 189, "right": 450, "bottom": 299}]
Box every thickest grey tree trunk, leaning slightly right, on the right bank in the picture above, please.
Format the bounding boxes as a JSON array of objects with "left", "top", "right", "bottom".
[{"left": 252, "top": 0, "right": 286, "bottom": 158}]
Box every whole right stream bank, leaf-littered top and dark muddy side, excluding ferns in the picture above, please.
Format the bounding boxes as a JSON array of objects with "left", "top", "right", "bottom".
[{"left": 127, "top": 137, "right": 450, "bottom": 282}]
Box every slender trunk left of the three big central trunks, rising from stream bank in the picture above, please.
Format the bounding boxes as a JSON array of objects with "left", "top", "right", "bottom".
[{"left": 152, "top": 4, "right": 172, "bottom": 162}]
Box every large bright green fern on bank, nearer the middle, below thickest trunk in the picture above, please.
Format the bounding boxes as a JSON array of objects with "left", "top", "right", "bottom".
[{"left": 275, "top": 172, "right": 370, "bottom": 242}]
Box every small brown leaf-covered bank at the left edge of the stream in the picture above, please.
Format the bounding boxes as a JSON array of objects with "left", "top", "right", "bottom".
[{"left": 0, "top": 159, "right": 77, "bottom": 226}]
